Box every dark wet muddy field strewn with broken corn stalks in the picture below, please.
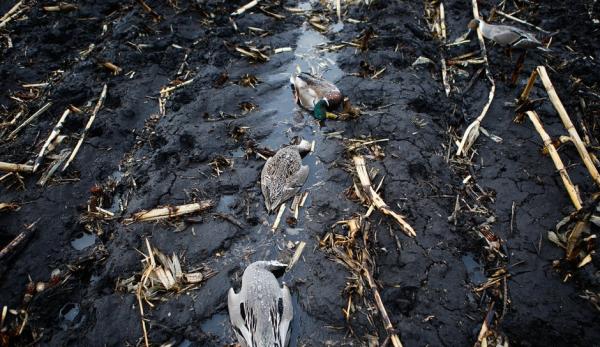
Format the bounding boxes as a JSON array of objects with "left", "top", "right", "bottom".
[{"left": 0, "top": 0, "right": 600, "bottom": 347}]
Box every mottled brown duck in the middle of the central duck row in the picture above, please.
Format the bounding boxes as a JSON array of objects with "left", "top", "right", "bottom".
[{"left": 260, "top": 140, "right": 311, "bottom": 212}]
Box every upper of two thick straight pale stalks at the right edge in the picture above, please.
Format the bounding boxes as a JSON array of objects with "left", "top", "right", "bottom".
[{"left": 537, "top": 66, "right": 600, "bottom": 186}]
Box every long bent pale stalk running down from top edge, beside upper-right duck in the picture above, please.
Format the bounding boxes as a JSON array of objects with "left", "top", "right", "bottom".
[{"left": 456, "top": 0, "right": 496, "bottom": 155}]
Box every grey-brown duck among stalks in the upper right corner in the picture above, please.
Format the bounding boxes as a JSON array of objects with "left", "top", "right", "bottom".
[{"left": 469, "top": 19, "right": 549, "bottom": 51}]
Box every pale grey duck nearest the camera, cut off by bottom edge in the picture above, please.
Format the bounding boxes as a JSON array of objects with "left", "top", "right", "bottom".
[{"left": 227, "top": 261, "right": 294, "bottom": 347}]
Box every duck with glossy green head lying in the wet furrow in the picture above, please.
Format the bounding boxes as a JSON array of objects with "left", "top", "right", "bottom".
[{"left": 290, "top": 72, "right": 343, "bottom": 121}]
